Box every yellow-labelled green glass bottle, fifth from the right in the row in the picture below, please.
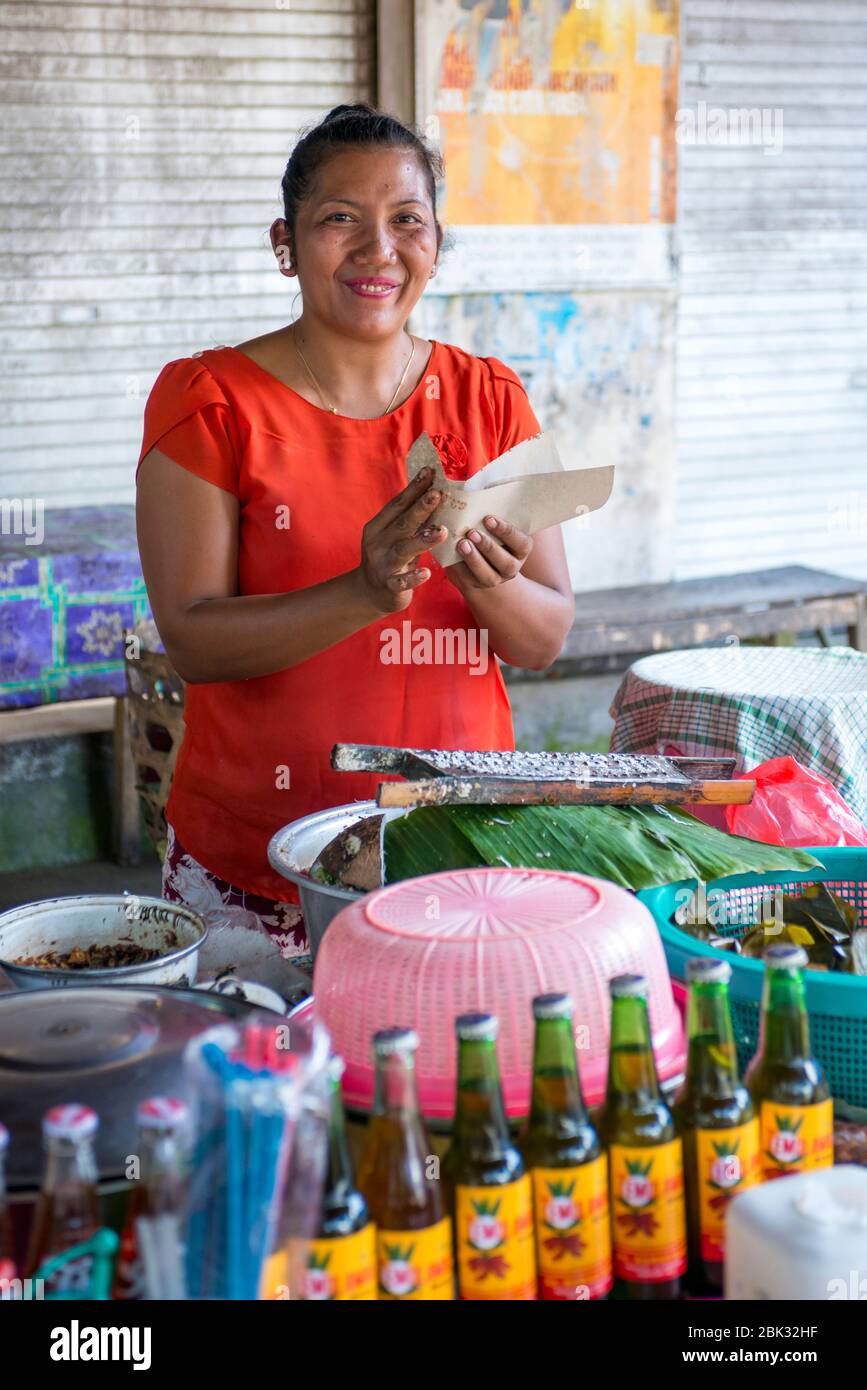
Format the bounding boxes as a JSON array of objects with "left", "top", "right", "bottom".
[{"left": 443, "top": 1013, "right": 536, "bottom": 1301}]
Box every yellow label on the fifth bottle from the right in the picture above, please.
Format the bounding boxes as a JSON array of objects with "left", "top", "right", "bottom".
[{"left": 454, "top": 1173, "right": 536, "bottom": 1301}]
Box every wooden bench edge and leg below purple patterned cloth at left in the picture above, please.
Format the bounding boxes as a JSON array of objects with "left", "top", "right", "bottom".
[{"left": 0, "top": 695, "right": 140, "bottom": 865}]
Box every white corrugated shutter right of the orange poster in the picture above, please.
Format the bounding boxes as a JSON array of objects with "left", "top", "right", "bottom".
[{"left": 677, "top": 0, "right": 867, "bottom": 577}]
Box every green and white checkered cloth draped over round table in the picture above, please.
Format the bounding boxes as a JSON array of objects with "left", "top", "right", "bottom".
[{"left": 610, "top": 646, "right": 867, "bottom": 824}]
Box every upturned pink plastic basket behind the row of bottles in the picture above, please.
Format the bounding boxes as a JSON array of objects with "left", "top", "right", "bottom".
[{"left": 313, "top": 869, "right": 685, "bottom": 1120}]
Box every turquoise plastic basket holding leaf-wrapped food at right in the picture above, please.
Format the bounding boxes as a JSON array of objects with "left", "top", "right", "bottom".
[{"left": 638, "top": 847, "right": 867, "bottom": 1109}]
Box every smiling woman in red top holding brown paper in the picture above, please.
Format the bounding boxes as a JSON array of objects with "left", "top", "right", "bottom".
[{"left": 138, "top": 107, "right": 572, "bottom": 949}]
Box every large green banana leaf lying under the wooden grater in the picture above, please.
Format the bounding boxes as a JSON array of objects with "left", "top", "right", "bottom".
[{"left": 383, "top": 805, "right": 818, "bottom": 890}]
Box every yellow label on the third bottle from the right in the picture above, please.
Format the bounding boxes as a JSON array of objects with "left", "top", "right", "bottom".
[{"left": 609, "top": 1138, "right": 686, "bottom": 1283}]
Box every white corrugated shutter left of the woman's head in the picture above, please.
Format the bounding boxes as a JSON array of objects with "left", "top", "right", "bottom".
[{"left": 0, "top": 0, "right": 375, "bottom": 506}]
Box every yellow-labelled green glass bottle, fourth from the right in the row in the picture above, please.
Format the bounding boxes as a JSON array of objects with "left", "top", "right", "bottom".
[{"left": 521, "top": 994, "right": 613, "bottom": 1302}]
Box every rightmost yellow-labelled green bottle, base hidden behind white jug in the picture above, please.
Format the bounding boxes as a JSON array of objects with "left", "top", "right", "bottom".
[{"left": 746, "top": 942, "right": 834, "bottom": 1182}]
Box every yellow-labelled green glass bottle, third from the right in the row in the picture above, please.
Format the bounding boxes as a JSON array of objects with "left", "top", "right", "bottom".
[{"left": 599, "top": 974, "right": 686, "bottom": 1300}]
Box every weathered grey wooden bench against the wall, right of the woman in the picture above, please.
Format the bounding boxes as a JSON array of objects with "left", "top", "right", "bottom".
[{"left": 554, "top": 564, "right": 867, "bottom": 674}]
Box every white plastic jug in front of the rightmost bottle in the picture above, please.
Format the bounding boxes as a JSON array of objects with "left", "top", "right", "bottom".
[{"left": 725, "top": 1165, "right": 867, "bottom": 1301}]
